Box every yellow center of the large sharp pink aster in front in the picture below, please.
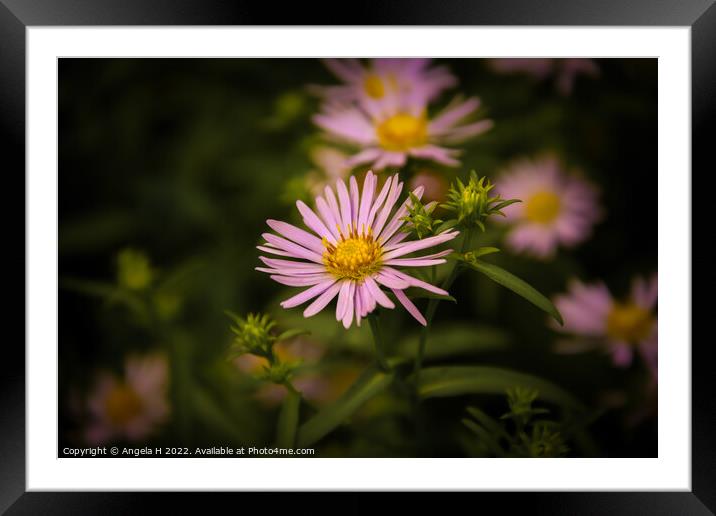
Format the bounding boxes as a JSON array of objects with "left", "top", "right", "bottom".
[{"left": 323, "top": 228, "right": 382, "bottom": 281}]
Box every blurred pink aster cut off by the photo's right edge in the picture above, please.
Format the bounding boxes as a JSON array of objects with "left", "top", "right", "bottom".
[{"left": 554, "top": 275, "right": 658, "bottom": 368}]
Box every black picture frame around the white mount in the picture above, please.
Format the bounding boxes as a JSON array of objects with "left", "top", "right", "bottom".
[{"left": 0, "top": 0, "right": 716, "bottom": 515}]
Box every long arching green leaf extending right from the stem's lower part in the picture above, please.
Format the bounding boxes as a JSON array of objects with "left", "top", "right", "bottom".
[{"left": 417, "top": 366, "right": 584, "bottom": 411}]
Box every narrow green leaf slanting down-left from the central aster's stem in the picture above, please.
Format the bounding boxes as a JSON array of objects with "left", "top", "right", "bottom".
[{"left": 296, "top": 367, "right": 394, "bottom": 448}]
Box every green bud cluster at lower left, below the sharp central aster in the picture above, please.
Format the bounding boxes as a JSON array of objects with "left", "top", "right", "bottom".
[{"left": 226, "top": 311, "right": 306, "bottom": 384}]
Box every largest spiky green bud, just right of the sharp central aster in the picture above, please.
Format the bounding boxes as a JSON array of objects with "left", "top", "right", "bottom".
[{"left": 440, "top": 170, "right": 520, "bottom": 231}]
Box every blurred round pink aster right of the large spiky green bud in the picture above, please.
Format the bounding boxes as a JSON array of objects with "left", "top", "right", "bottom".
[{"left": 496, "top": 156, "right": 600, "bottom": 259}]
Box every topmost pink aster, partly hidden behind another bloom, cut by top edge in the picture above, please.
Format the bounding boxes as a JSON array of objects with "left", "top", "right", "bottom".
[{"left": 319, "top": 59, "right": 457, "bottom": 104}]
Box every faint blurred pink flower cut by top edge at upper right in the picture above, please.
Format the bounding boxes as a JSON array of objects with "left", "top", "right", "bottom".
[{"left": 489, "top": 58, "right": 599, "bottom": 95}]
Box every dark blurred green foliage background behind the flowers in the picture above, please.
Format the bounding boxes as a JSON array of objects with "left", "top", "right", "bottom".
[{"left": 59, "top": 59, "right": 657, "bottom": 457}]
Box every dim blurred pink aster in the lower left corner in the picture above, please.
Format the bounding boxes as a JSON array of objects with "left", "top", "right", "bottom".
[{"left": 86, "top": 355, "right": 169, "bottom": 445}]
